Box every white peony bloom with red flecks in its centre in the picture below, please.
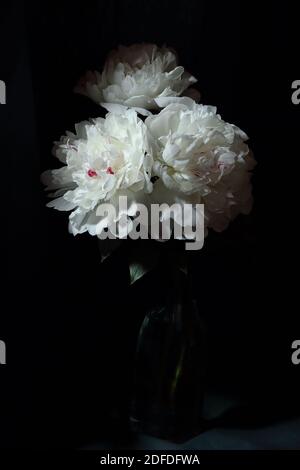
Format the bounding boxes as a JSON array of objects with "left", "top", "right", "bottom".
[{"left": 42, "top": 109, "right": 152, "bottom": 237}]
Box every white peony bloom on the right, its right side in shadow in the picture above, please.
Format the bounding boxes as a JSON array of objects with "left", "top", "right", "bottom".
[{"left": 145, "top": 98, "right": 255, "bottom": 231}]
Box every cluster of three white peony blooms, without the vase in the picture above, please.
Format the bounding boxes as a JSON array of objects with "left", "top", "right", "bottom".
[{"left": 42, "top": 44, "right": 255, "bottom": 280}]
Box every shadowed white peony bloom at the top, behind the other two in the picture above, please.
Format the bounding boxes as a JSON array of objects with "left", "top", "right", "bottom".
[{"left": 75, "top": 44, "right": 197, "bottom": 112}]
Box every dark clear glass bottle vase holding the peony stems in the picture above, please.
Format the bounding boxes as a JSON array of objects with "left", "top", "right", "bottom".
[{"left": 131, "top": 268, "right": 206, "bottom": 441}]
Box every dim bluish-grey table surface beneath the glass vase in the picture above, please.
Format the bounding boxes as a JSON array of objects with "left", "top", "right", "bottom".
[{"left": 83, "top": 396, "right": 300, "bottom": 450}]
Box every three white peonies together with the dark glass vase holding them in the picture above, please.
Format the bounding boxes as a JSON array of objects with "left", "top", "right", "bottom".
[{"left": 42, "top": 44, "right": 255, "bottom": 436}]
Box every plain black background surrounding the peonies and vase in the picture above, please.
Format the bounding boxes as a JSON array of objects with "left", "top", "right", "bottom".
[{"left": 0, "top": 0, "right": 300, "bottom": 447}]
